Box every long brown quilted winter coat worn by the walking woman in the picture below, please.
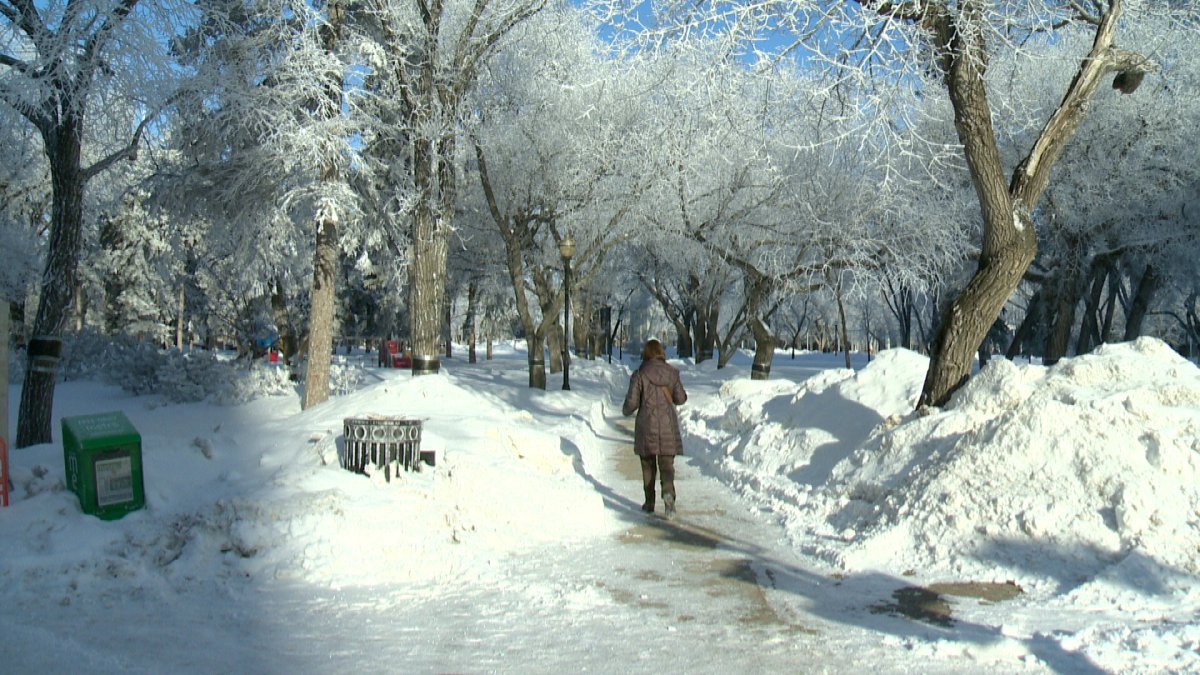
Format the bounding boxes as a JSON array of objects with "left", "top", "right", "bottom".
[{"left": 620, "top": 359, "right": 688, "bottom": 458}]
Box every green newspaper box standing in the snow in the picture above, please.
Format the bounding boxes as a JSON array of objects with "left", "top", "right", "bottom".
[{"left": 62, "top": 412, "right": 145, "bottom": 520}]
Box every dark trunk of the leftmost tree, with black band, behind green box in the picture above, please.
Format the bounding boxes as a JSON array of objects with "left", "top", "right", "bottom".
[{"left": 16, "top": 121, "right": 85, "bottom": 448}]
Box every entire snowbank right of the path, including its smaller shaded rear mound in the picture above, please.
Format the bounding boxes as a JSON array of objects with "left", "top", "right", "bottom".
[{"left": 686, "top": 339, "right": 1200, "bottom": 593}]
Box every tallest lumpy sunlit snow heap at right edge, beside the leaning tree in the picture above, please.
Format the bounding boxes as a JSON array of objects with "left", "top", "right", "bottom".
[{"left": 829, "top": 339, "right": 1200, "bottom": 583}]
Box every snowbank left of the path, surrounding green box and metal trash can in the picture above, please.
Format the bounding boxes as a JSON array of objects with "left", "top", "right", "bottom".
[{"left": 0, "top": 369, "right": 617, "bottom": 603}]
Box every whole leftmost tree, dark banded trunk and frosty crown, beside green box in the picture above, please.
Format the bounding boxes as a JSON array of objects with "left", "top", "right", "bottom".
[{"left": 0, "top": 0, "right": 190, "bottom": 447}]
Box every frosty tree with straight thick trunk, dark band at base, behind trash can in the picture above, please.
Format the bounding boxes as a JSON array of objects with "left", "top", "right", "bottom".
[{"left": 350, "top": 0, "right": 546, "bottom": 375}]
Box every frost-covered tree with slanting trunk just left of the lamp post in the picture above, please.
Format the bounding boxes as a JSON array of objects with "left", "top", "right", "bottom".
[{"left": 470, "top": 10, "right": 654, "bottom": 388}]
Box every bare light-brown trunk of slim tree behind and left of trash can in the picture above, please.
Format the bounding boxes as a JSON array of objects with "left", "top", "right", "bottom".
[{"left": 300, "top": 214, "right": 337, "bottom": 410}]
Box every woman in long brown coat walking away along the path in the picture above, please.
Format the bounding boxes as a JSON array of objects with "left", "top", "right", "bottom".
[{"left": 620, "top": 338, "right": 688, "bottom": 518}]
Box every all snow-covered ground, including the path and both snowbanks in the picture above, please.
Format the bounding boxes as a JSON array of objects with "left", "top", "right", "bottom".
[{"left": 0, "top": 339, "right": 1200, "bottom": 673}]
